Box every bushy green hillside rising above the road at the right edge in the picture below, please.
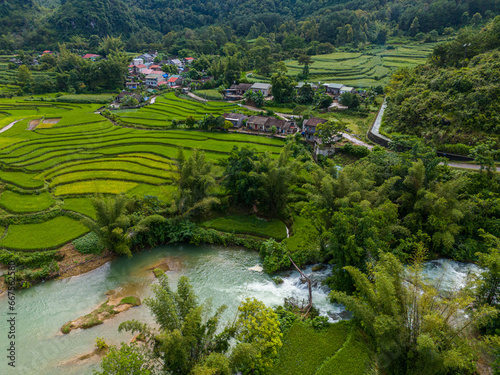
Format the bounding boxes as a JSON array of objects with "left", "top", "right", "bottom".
[{"left": 385, "top": 17, "right": 500, "bottom": 151}]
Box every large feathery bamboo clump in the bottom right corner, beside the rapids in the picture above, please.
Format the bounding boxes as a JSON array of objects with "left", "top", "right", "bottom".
[{"left": 330, "top": 253, "right": 496, "bottom": 374}]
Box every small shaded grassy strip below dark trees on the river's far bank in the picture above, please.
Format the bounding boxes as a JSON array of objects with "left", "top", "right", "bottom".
[{"left": 201, "top": 215, "right": 286, "bottom": 241}]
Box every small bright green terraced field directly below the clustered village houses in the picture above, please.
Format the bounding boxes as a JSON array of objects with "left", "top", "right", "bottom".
[{"left": 115, "top": 92, "right": 240, "bottom": 128}]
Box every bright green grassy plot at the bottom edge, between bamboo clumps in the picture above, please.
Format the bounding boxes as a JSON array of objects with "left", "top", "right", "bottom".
[{"left": 272, "top": 322, "right": 369, "bottom": 375}]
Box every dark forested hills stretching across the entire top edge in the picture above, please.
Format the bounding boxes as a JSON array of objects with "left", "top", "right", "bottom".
[{"left": 0, "top": 0, "right": 500, "bottom": 50}]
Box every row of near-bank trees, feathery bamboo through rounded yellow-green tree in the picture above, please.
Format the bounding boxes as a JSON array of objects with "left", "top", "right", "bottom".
[{"left": 96, "top": 273, "right": 282, "bottom": 375}]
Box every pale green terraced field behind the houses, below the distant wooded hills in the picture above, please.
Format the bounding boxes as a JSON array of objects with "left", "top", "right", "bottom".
[{"left": 250, "top": 43, "right": 435, "bottom": 87}]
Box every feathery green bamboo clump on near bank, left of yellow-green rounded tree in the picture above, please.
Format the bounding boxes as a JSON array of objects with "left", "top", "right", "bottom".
[{"left": 111, "top": 273, "right": 235, "bottom": 375}]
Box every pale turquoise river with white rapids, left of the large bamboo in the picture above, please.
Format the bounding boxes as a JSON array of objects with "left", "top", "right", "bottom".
[{"left": 0, "top": 245, "right": 343, "bottom": 375}]
